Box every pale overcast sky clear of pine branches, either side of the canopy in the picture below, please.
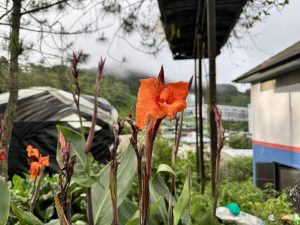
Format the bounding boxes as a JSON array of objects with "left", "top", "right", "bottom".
[{"left": 71, "top": 0, "right": 300, "bottom": 90}]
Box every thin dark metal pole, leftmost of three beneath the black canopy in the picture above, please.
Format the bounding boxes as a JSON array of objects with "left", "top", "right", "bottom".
[{"left": 194, "top": 59, "right": 200, "bottom": 183}]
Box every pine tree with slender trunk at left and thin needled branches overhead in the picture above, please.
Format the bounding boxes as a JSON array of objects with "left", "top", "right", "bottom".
[{"left": 0, "top": 0, "right": 163, "bottom": 176}]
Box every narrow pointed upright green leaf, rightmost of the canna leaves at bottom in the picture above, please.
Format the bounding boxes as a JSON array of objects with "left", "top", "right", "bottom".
[{"left": 173, "top": 173, "right": 190, "bottom": 225}]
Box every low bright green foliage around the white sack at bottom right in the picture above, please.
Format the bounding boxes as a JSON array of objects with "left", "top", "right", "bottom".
[{"left": 191, "top": 180, "right": 293, "bottom": 225}]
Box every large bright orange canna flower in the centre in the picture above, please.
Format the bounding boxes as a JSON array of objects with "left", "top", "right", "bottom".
[{"left": 136, "top": 78, "right": 189, "bottom": 129}]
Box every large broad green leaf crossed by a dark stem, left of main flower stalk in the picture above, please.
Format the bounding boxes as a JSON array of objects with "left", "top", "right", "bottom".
[{"left": 92, "top": 147, "right": 136, "bottom": 225}]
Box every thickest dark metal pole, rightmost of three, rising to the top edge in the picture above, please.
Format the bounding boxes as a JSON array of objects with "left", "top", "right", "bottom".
[{"left": 207, "top": 0, "right": 217, "bottom": 201}]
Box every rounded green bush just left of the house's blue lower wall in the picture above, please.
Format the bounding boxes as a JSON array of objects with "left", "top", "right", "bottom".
[{"left": 220, "top": 156, "right": 253, "bottom": 181}]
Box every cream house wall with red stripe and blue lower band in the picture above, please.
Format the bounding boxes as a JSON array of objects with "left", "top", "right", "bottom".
[{"left": 251, "top": 76, "right": 300, "bottom": 184}]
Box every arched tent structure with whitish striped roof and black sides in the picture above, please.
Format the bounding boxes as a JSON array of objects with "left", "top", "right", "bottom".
[{"left": 0, "top": 87, "right": 118, "bottom": 177}]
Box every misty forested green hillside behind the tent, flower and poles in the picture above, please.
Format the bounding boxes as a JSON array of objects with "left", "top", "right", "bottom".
[{"left": 0, "top": 58, "right": 250, "bottom": 116}]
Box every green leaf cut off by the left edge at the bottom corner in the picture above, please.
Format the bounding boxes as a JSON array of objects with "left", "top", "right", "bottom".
[{"left": 0, "top": 176, "right": 10, "bottom": 225}]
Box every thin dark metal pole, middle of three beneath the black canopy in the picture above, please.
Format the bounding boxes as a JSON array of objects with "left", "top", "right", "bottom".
[{"left": 197, "top": 35, "right": 205, "bottom": 194}]
